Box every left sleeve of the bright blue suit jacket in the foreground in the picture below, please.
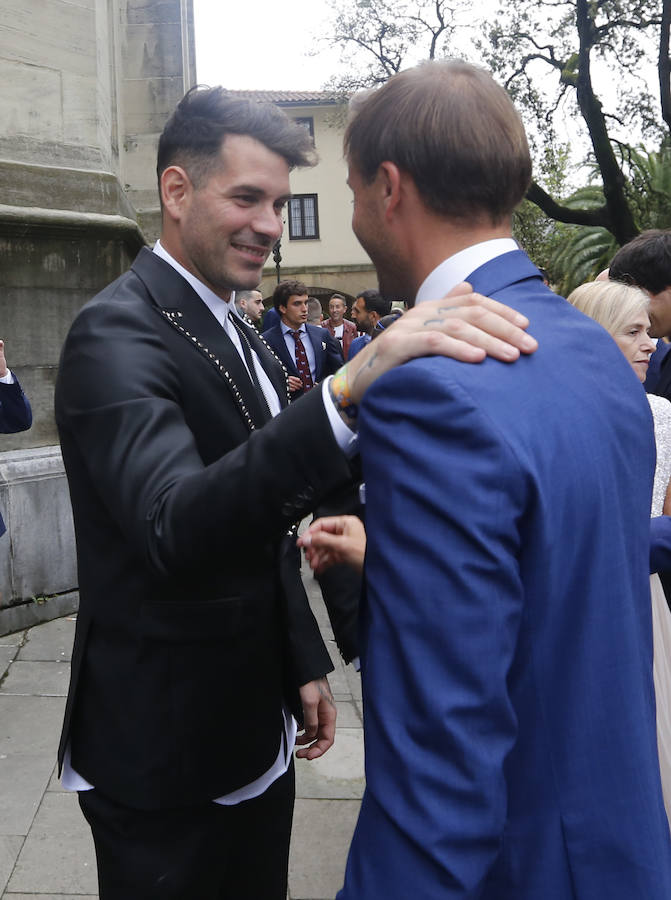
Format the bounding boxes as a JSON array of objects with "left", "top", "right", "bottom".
[{"left": 339, "top": 360, "right": 525, "bottom": 900}]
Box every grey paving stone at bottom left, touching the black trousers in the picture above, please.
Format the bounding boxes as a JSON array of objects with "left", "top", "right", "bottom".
[{"left": 7, "top": 793, "right": 98, "bottom": 900}]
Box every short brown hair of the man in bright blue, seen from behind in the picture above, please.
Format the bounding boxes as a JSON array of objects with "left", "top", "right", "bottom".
[{"left": 345, "top": 60, "right": 531, "bottom": 224}]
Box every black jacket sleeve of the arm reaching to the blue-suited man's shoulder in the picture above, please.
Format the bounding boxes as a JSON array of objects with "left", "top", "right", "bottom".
[{"left": 57, "top": 300, "right": 350, "bottom": 576}]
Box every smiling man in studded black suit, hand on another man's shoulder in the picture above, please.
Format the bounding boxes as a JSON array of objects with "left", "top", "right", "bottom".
[{"left": 56, "top": 88, "right": 540, "bottom": 900}]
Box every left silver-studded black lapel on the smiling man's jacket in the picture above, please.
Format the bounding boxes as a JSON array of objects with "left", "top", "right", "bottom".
[{"left": 132, "top": 248, "right": 287, "bottom": 431}]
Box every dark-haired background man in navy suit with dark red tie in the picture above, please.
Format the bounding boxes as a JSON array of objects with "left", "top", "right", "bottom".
[{"left": 263, "top": 281, "right": 344, "bottom": 400}]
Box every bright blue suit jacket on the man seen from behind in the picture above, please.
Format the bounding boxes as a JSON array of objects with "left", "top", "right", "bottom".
[{"left": 338, "top": 251, "right": 671, "bottom": 900}]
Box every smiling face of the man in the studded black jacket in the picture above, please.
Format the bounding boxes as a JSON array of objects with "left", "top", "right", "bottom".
[{"left": 161, "top": 134, "right": 290, "bottom": 300}]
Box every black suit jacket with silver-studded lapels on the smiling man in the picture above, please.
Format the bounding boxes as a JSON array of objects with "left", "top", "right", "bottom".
[{"left": 56, "top": 250, "right": 350, "bottom": 809}]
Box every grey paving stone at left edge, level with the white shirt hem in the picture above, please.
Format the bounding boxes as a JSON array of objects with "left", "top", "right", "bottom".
[{"left": 0, "top": 752, "right": 54, "bottom": 835}]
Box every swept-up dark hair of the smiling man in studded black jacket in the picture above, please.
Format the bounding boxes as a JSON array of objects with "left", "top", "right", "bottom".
[{"left": 156, "top": 85, "right": 316, "bottom": 194}]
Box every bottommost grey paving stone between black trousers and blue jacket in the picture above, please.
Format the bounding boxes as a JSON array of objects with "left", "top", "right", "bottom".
[{"left": 289, "top": 800, "right": 359, "bottom": 900}]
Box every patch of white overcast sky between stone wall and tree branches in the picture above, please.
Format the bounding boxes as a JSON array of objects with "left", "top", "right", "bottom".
[{"left": 193, "top": 0, "right": 338, "bottom": 90}]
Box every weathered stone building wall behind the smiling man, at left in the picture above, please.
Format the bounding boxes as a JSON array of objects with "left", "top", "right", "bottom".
[{"left": 0, "top": 0, "right": 195, "bottom": 634}]
